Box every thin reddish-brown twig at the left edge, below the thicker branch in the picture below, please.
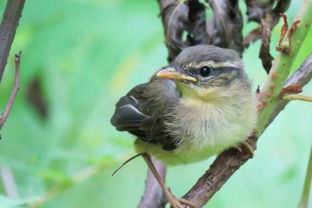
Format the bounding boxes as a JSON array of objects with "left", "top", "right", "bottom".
[{"left": 0, "top": 52, "right": 22, "bottom": 129}]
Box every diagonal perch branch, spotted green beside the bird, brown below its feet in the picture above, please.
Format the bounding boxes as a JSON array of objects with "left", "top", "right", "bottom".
[{"left": 184, "top": 1, "right": 312, "bottom": 206}]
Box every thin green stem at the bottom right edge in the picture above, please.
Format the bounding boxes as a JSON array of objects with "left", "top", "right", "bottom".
[{"left": 298, "top": 148, "right": 312, "bottom": 208}]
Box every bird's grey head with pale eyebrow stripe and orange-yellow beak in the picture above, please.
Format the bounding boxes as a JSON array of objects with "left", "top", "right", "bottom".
[{"left": 156, "top": 45, "right": 250, "bottom": 100}]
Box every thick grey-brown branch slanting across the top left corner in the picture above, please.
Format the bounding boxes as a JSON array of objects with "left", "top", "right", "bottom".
[{"left": 0, "top": 0, "right": 25, "bottom": 83}]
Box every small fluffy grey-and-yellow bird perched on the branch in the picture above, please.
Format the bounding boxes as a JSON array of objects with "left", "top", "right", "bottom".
[{"left": 111, "top": 45, "right": 257, "bottom": 208}]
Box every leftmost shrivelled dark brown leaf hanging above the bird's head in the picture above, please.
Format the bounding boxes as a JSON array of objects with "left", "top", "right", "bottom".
[{"left": 161, "top": 0, "right": 209, "bottom": 62}]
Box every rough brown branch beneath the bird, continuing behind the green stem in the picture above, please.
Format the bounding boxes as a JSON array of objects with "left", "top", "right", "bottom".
[{"left": 183, "top": 55, "right": 312, "bottom": 206}]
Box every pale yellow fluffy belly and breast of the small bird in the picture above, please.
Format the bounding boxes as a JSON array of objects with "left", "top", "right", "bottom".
[{"left": 155, "top": 98, "right": 256, "bottom": 164}]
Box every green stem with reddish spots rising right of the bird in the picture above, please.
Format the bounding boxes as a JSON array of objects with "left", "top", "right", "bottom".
[{"left": 256, "top": 0, "right": 312, "bottom": 136}]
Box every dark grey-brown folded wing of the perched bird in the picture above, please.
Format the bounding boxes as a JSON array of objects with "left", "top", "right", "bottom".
[{"left": 111, "top": 81, "right": 180, "bottom": 150}]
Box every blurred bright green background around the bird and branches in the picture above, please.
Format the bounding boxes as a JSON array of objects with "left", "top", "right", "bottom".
[{"left": 0, "top": 0, "right": 312, "bottom": 208}]
